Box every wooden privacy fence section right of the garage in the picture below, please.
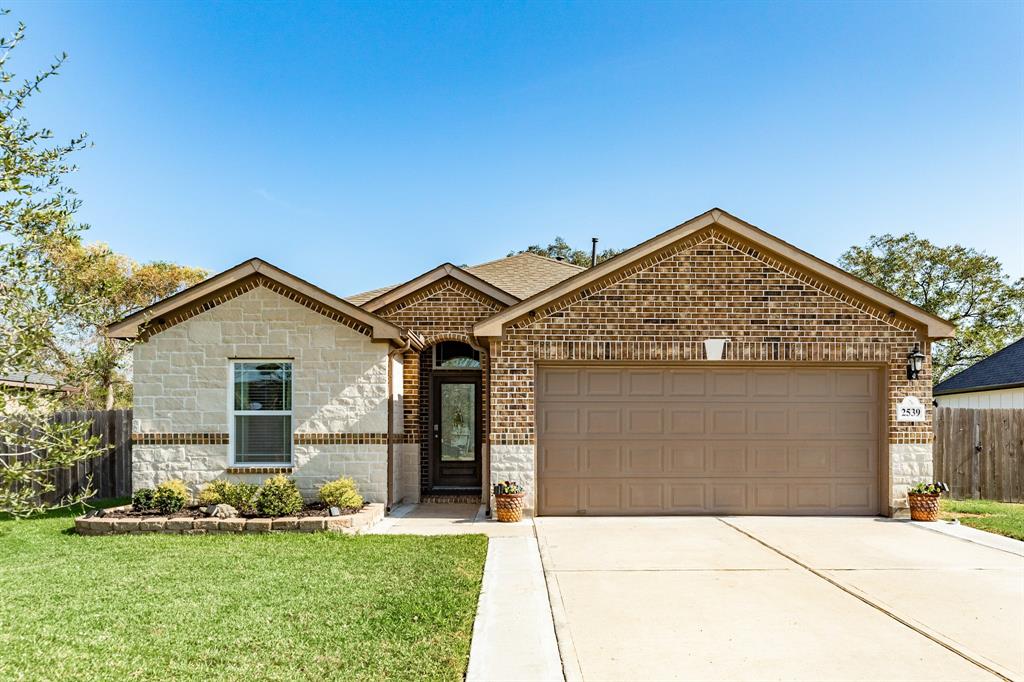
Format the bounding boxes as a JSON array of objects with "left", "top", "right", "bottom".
[{"left": 934, "top": 408, "right": 1024, "bottom": 502}]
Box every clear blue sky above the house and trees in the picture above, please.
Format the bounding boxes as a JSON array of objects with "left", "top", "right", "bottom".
[{"left": 4, "top": 2, "right": 1024, "bottom": 295}]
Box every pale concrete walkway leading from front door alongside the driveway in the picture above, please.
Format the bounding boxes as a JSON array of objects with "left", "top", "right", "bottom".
[{"left": 371, "top": 504, "right": 563, "bottom": 682}]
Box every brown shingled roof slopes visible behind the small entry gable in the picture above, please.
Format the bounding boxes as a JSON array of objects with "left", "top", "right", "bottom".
[{"left": 346, "top": 252, "right": 586, "bottom": 305}]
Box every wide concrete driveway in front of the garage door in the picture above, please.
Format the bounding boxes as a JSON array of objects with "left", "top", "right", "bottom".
[{"left": 536, "top": 516, "right": 1024, "bottom": 682}]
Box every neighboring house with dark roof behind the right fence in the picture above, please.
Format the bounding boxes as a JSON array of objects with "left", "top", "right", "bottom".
[{"left": 932, "top": 339, "right": 1024, "bottom": 410}]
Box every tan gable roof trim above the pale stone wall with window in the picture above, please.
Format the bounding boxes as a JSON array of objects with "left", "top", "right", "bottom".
[{"left": 106, "top": 258, "right": 420, "bottom": 345}]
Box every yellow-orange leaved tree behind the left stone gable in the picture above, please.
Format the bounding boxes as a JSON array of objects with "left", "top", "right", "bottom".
[{"left": 47, "top": 236, "right": 207, "bottom": 410}]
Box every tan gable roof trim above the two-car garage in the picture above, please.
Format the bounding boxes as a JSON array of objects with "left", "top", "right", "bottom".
[{"left": 473, "top": 204, "right": 953, "bottom": 339}]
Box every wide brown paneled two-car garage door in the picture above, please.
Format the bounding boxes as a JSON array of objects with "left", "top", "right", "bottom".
[{"left": 537, "top": 366, "right": 880, "bottom": 515}]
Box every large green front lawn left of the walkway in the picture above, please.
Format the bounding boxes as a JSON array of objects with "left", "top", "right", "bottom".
[{"left": 0, "top": 497, "right": 487, "bottom": 681}]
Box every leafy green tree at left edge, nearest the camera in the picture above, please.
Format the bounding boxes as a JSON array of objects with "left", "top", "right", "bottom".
[{"left": 0, "top": 11, "right": 103, "bottom": 515}]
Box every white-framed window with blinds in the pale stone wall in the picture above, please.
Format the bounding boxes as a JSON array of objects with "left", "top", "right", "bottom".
[{"left": 231, "top": 360, "right": 292, "bottom": 465}]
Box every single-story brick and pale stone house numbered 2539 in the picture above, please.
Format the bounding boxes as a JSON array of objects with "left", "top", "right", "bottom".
[{"left": 109, "top": 209, "right": 952, "bottom": 515}]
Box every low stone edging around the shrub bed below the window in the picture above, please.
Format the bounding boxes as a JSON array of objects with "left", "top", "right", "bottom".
[{"left": 75, "top": 503, "right": 384, "bottom": 536}]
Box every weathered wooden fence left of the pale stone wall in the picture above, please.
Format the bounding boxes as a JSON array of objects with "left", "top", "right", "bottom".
[{"left": 0, "top": 410, "right": 131, "bottom": 502}]
